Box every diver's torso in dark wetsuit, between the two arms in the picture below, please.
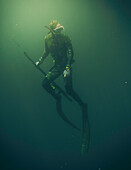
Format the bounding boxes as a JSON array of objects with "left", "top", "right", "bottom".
[{"left": 46, "top": 33, "right": 68, "bottom": 65}]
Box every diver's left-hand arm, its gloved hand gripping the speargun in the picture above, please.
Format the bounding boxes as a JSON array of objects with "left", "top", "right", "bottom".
[{"left": 36, "top": 39, "right": 49, "bottom": 66}]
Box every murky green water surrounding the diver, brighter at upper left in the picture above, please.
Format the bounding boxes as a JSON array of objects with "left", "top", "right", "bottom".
[{"left": 0, "top": 0, "right": 131, "bottom": 170}]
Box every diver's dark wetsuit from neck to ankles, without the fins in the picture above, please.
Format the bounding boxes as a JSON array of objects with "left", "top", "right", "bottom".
[{"left": 39, "top": 33, "right": 83, "bottom": 105}]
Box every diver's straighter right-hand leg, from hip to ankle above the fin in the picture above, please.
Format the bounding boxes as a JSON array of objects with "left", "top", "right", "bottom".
[{"left": 65, "top": 69, "right": 84, "bottom": 106}]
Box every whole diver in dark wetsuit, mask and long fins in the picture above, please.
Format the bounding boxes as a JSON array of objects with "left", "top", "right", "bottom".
[{"left": 35, "top": 20, "right": 89, "bottom": 153}]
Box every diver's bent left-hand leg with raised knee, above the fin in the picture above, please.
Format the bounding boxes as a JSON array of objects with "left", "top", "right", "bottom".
[{"left": 42, "top": 67, "right": 62, "bottom": 99}]
